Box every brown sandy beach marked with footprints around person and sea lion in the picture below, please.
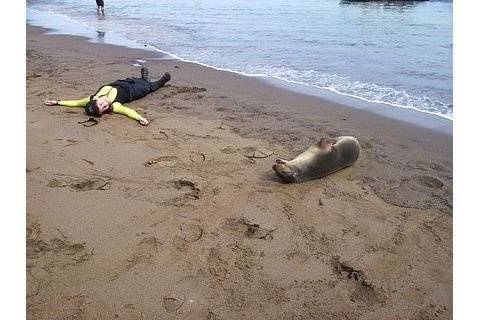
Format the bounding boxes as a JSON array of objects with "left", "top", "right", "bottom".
[{"left": 26, "top": 26, "right": 452, "bottom": 319}]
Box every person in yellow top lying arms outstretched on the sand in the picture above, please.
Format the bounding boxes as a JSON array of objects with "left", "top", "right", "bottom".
[{"left": 44, "top": 67, "right": 171, "bottom": 126}]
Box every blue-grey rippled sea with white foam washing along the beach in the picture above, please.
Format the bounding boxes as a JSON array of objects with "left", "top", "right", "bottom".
[{"left": 26, "top": 0, "right": 453, "bottom": 120}]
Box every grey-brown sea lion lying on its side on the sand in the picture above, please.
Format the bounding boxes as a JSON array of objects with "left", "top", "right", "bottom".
[{"left": 272, "top": 136, "right": 360, "bottom": 182}]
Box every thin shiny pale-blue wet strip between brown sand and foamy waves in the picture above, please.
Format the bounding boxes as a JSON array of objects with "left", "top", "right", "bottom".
[{"left": 26, "top": 10, "right": 453, "bottom": 131}]
